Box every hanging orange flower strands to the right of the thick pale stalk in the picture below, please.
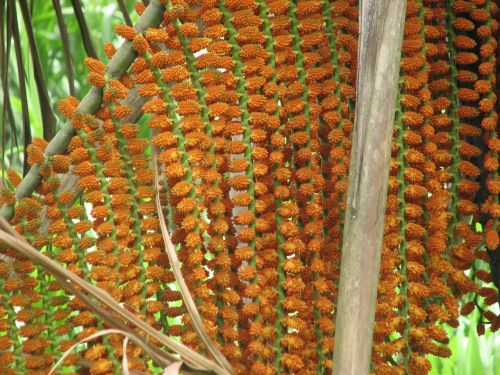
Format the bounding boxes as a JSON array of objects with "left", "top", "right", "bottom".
[{"left": 373, "top": 0, "right": 499, "bottom": 374}]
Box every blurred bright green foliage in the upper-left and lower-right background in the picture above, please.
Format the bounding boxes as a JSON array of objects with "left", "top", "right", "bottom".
[{"left": 0, "top": 0, "right": 500, "bottom": 375}]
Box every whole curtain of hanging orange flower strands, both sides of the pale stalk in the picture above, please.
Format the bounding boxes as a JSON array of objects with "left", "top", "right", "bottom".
[{"left": 0, "top": 0, "right": 500, "bottom": 374}]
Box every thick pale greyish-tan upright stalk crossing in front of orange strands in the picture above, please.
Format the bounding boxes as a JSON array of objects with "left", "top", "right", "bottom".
[{"left": 333, "top": 0, "right": 406, "bottom": 375}]
